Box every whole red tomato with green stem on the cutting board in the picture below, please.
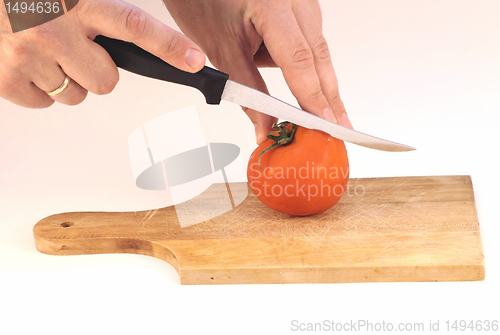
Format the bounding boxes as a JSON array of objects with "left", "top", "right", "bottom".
[{"left": 247, "top": 122, "right": 349, "bottom": 216}]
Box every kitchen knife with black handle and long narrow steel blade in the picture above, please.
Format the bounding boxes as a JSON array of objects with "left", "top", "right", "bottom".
[{"left": 95, "top": 36, "right": 415, "bottom": 151}]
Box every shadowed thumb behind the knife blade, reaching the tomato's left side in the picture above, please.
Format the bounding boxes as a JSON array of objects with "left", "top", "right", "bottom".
[{"left": 209, "top": 46, "right": 276, "bottom": 144}]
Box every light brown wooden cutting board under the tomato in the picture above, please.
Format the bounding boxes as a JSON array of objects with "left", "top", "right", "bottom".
[{"left": 34, "top": 176, "right": 484, "bottom": 284}]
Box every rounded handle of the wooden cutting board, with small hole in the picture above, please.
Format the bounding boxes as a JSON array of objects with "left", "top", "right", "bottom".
[{"left": 34, "top": 213, "right": 179, "bottom": 270}]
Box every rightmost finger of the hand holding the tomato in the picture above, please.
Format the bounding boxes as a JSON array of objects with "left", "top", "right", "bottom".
[{"left": 293, "top": 0, "right": 352, "bottom": 128}]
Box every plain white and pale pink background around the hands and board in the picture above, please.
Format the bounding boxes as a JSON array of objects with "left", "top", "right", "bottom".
[{"left": 0, "top": 0, "right": 500, "bottom": 334}]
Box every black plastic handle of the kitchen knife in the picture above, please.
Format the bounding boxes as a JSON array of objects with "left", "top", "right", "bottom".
[{"left": 94, "top": 36, "right": 229, "bottom": 105}]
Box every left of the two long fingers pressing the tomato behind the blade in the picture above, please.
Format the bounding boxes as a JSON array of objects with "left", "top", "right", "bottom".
[{"left": 254, "top": 2, "right": 333, "bottom": 118}]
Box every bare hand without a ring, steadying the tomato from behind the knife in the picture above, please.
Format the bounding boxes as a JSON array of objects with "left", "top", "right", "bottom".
[{"left": 163, "top": 0, "right": 352, "bottom": 144}]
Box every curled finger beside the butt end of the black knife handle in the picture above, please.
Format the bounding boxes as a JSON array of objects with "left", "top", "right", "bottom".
[{"left": 56, "top": 36, "right": 119, "bottom": 95}]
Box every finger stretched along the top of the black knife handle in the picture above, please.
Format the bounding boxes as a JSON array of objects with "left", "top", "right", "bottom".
[{"left": 81, "top": 0, "right": 205, "bottom": 72}]
